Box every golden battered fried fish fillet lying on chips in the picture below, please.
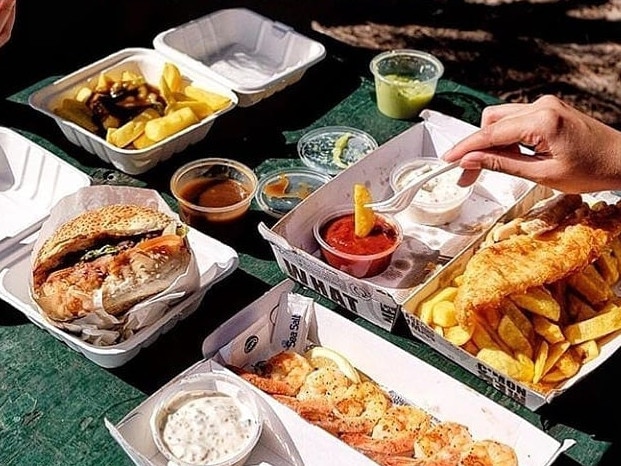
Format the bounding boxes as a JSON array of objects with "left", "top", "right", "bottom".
[{"left": 455, "top": 196, "right": 621, "bottom": 329}]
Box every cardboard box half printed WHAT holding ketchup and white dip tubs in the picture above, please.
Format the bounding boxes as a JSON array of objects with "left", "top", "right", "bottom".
[{"left": 259, "top": 110, "right": 551, "bottom": 330}]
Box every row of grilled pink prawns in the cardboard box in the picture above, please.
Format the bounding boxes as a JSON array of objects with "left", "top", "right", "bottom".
[{"left": 231, "top": 351, "right": 518, "bottom": 466}]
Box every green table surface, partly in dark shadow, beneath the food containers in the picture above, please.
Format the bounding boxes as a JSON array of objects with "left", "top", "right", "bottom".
[{"left": 0, "top": 4, "right": 621, "bottom": 466}]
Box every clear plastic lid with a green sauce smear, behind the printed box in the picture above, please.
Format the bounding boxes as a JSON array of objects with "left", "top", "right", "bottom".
[{"left": 298, "top": 126, "right": 378, "bottom": 175}]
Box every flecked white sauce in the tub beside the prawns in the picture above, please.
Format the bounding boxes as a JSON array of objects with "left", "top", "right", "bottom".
[{"left": 161, "top": 391, "right": 257, "bottom": 465}]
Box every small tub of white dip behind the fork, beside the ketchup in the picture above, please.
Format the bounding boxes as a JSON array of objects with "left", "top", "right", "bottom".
[{"left": 390, "top": 157, "right": 474, "bottom": 226}]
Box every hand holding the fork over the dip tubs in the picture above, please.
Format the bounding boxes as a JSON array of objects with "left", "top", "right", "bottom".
[{"left": 443, "top": 95, "right": 621, "bottom": 193}]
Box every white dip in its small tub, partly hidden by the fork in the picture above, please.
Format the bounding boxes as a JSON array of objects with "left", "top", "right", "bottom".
[{"left": 396, "top": 164, "right": 470, "bottom": 225}]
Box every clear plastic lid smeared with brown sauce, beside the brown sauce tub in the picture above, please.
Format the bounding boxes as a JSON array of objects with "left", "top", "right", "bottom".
[{"left": 255, "top": 167, "right": 331, "bottom": 218}]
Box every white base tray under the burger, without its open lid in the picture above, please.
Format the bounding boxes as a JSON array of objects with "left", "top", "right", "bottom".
[{"left": 0, "top": 224, "right": 238, "bottom": 368}]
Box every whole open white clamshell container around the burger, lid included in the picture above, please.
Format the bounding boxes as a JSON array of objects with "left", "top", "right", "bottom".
[{"left": 0, "top": 138, "right": 238, "bottom": 368}]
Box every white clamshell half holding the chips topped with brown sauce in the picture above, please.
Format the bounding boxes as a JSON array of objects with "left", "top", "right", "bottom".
[{"left": 29, "top": 48, "right": 237, "bottom": 175}]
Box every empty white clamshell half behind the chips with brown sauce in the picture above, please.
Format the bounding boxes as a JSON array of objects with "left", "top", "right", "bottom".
[{"left": 154, "top": 8, "right": 326, "bottom": 107}]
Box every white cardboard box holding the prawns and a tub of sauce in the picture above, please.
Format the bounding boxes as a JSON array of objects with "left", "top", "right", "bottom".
[{"left": 106, "top": 280, "right": 575, "bottom": 466}]
